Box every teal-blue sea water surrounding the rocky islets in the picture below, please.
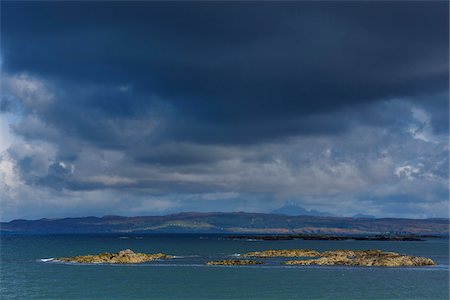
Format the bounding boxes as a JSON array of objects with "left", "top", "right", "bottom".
[{"left": 0, "top": 235, "right": 449, "bottom": 299}]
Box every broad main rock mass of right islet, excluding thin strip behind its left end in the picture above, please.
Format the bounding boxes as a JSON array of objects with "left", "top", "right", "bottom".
[{"left": 285, "top": 250, "right": 436, "bottom": 267}]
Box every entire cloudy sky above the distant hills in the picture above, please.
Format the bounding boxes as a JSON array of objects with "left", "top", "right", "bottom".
[{"left": 0, "top": 1, "right": 449, "bottom": 221}]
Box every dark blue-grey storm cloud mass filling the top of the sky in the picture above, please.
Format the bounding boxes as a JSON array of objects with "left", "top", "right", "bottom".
[{"left": 2, "top": 2, "right": 448, "bottom": 146}]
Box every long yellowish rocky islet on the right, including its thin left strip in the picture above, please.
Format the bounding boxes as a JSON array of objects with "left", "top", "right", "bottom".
[{"left": 243, "top": 249, "right": 436, "bottom": 267}]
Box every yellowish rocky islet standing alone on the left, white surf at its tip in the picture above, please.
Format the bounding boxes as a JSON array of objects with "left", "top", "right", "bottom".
[{"left": 55, "top": 249, "right": 173, "bottom": 264}]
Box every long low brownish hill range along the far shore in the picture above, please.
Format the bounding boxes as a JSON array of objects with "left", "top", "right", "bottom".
[{"left": 0, "top": 212, "right": 449, "bottom": 234}]
